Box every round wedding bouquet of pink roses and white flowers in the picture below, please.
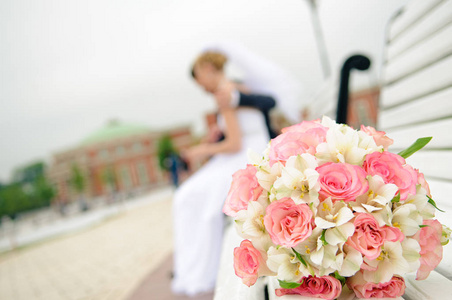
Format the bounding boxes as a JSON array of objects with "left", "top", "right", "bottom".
[{"left": 223, "top": 117, "right": 451, "bottom": 299}]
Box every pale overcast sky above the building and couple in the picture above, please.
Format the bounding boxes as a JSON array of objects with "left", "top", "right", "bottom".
[{"left": 0, "top": 0, "right": 408, "bottom": 181}]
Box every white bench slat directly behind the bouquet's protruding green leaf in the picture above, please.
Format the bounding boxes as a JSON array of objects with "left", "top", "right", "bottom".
[{"left": 379, "top": 118, "right": 452, "bottom": 150}]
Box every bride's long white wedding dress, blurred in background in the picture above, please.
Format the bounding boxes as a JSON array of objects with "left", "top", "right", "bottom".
[{"left": 172, "top": 108, "right": 269, "bottom": 296}]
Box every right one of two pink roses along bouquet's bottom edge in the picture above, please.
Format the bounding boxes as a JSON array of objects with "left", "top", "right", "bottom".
[{"left": 347, "top": 271, "right": 405, "bottom": 299}]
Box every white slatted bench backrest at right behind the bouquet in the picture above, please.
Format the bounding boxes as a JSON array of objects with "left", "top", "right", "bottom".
[{"left": 378, "top": 0, "right": 452, "bottom": 279}]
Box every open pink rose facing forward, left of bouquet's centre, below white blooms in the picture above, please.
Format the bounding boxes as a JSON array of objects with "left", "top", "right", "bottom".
[{"left": 264, "top": 198, "right": 313, "bottom": 247}]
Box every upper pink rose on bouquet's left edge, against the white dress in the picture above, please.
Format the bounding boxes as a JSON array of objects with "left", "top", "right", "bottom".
[{"left": 223, "top": 165, "right": 263, "bottom": 217}]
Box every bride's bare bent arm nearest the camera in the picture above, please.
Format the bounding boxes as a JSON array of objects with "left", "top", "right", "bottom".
[{"left": 185, "top": 108, "right": 242, "bottom": 160}]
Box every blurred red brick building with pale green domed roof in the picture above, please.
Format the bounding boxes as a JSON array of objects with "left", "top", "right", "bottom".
[{"left": 48, "top": 121, "right": 192, "bottom": 203}]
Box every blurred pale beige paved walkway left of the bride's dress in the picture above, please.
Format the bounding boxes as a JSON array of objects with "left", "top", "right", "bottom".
[{"left": 0, "top": 189, "right": 172, "bottom": 300}]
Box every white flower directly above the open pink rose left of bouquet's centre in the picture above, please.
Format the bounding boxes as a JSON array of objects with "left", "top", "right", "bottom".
[{"left": 273, "top": 153, "right": 320, "bottom": 206}]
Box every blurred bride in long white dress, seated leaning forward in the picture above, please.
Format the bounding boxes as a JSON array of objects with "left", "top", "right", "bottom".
[{"left": 172, "top": 44, "right": 298, "bottom": 296}]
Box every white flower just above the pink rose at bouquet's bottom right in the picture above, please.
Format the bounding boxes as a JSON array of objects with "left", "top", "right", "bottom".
[{"left": 363, "top": 242, "right": 410, "bottom": 283}]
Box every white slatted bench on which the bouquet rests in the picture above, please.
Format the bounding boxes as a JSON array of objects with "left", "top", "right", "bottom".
[{"left": 214, "top": 0, "right": 452, "bottom": 300}]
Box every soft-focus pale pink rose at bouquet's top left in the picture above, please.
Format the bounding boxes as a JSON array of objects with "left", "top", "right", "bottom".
[{"left": 268, "top": 128, "right": 326, "bottom": 165}]
